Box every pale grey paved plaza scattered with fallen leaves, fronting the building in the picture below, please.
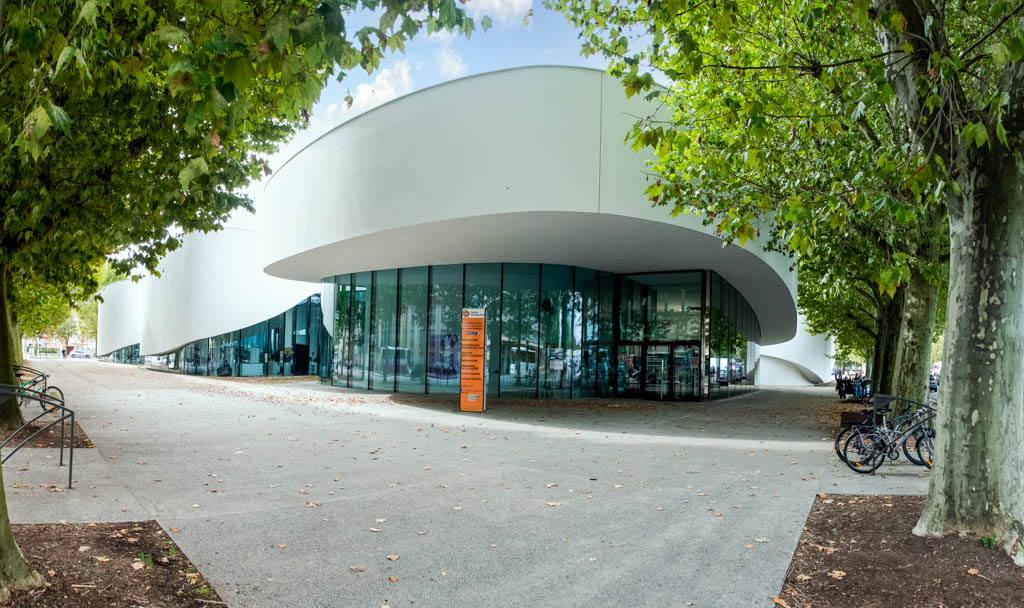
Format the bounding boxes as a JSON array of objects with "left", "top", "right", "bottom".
[{"left": 3, "top": 360, "right": 927, "bottom": 608}]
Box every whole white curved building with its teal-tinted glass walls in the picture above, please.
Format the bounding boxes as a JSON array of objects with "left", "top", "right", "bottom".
[{"left": 100, "top": 67, "right": 797, "bottom": 399}]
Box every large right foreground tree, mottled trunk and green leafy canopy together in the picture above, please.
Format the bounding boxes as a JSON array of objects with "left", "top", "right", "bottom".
[{"left": 551, "top": 0, "right": 1024, "bottom": 565}]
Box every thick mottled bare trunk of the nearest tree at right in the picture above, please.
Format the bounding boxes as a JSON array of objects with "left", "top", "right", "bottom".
[{"left": 914, "top": 150, "right": 1024, "bottom": 566}]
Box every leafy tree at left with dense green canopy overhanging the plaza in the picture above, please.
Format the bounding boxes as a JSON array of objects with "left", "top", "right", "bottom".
[{"left": 0, "top": 0, "right": 479, "bottom": 601}]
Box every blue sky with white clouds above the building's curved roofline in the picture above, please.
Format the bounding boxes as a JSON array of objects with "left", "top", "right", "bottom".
[{"left": 231, "top": 0, "right": 605, "bottom": 227}]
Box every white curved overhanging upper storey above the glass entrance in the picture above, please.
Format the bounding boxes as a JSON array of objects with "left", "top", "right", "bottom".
[{"left": 259, "top": 67, "right": 797, "bottom": 344}]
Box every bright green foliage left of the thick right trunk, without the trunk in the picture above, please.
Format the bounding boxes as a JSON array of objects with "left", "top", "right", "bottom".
[{"left": 548, "top": 0, "right": 954, "bottom": 296}]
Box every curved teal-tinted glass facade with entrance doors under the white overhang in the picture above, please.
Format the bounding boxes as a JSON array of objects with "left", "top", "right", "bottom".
[{"left": 323, "top": 263, "right": 760, "bottom": 400}]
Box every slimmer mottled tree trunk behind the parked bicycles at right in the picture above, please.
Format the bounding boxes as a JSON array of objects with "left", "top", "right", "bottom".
[{"left": 892, "top": 269, "right": 939, "bottom": 403}]
